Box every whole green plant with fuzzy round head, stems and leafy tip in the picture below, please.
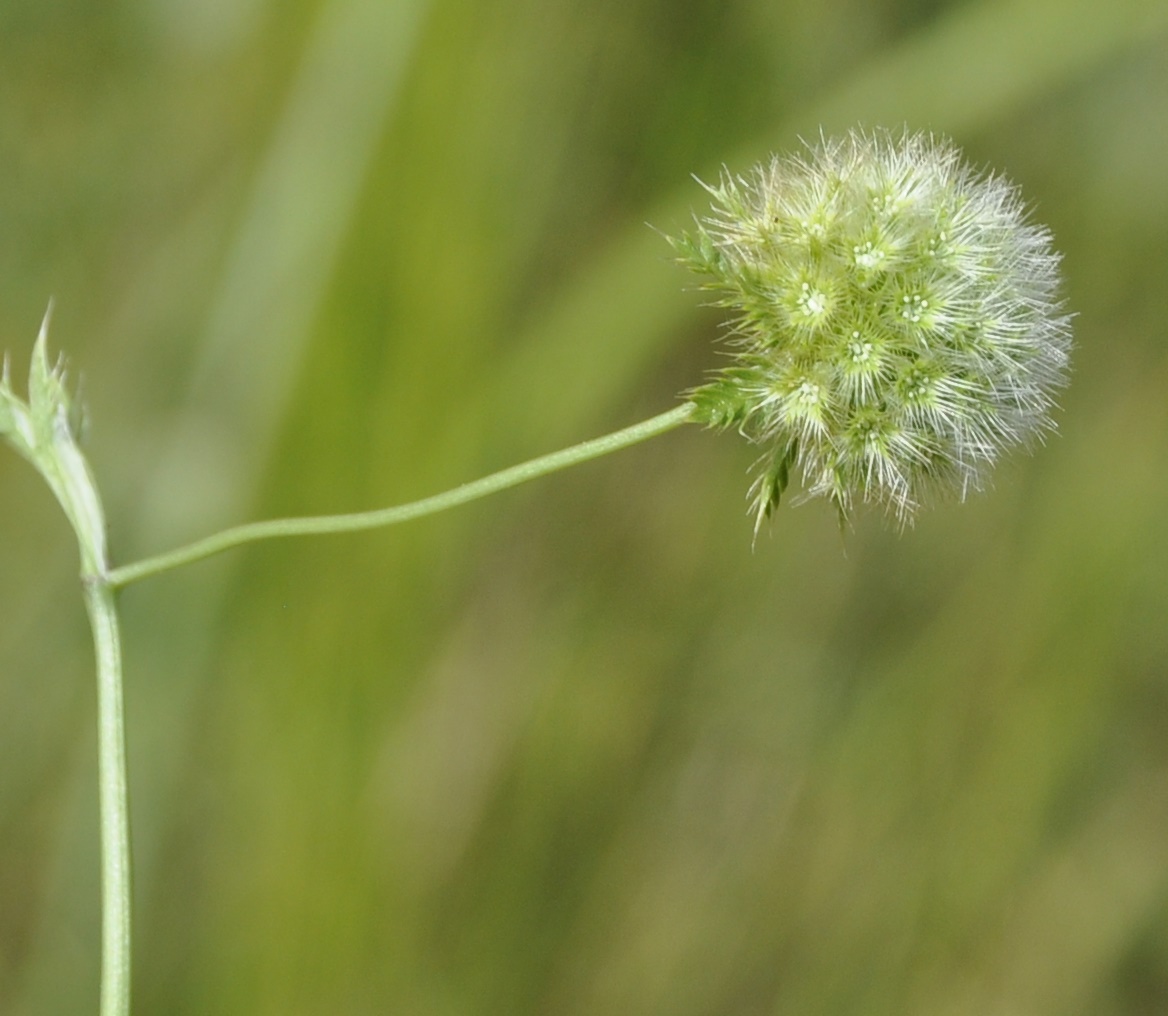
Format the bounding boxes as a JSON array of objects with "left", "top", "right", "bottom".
[{"left": 0, "top": 130, "right": 1070, "bottom": 1016}]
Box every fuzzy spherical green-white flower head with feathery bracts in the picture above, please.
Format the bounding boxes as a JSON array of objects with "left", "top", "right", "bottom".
[{"left": 672, "top": 130, "right": 1070, "bottom": 524}]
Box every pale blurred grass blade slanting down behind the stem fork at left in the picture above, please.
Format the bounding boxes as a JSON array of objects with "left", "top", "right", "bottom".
[{"left": 15, "top": 0, "right": 427, "bottom": 1012}]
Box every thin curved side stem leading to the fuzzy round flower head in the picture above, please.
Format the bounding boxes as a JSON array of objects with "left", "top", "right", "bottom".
[{"left": 105, "top": 402, "right": 694, "bottom": 589}]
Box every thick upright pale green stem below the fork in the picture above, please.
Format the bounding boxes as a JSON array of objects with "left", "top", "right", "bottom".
[{"left": 82, "top": 575, "right": 131, "bottom": 1016}]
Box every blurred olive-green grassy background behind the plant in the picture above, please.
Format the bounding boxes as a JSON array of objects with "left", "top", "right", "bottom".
[{"left": 0, "top": 0, "right": 1168, "bottom": 1016}]
